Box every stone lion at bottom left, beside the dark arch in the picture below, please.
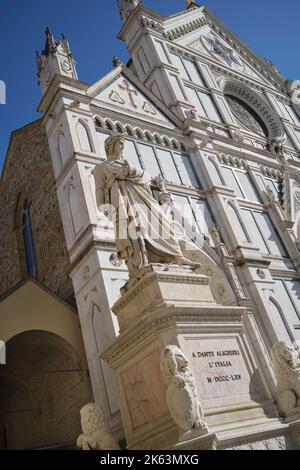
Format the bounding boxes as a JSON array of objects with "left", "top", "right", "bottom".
[{"left": 77, "top": 403, "right": 120, "bottom": 450}]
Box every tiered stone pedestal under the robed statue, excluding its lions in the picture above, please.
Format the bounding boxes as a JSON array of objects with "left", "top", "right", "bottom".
[{"left": 101, "top": 265, "right": 296, "bottom": 449}]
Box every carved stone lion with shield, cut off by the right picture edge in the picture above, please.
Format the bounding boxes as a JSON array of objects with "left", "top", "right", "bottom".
[{"left": 272, "top": 341, "right": 300, "bottom": 416}]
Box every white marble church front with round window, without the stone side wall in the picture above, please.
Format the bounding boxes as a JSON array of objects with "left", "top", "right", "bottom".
[{"left": 39, "top": 1, "right": 300, "bottom": 437}]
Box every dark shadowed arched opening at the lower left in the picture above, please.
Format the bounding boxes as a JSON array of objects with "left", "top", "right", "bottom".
[{"left": 0, "top": 330, "right": 92, "bottom": 450}]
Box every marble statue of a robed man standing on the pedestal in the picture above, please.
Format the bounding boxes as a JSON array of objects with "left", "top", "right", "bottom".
[{"left": 94, "top": 134, "right": 185, "bottom": 275}]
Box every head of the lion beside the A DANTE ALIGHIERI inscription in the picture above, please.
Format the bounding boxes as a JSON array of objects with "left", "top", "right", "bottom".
[{"left": 160, "top": 345, "right": 189, "bottom": 381}]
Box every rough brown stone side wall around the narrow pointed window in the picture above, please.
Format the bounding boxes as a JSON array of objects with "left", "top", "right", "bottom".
[{"left": 0, "top": 120, "right": 75, "bottom": 304}]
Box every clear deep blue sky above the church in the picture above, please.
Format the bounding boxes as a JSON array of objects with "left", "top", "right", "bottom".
[{"left": 0, "top": 0, "right": 300, "bottom": 172}]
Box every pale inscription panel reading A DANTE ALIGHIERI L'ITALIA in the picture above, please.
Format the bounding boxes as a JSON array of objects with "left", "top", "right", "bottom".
[{"left": 186, "top": 338, "right": 250, "bottom": 400}]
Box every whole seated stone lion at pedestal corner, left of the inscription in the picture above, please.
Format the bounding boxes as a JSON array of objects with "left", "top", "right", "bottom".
[{"left": 160, "top": 345, "right": 207, "bottom": 432}]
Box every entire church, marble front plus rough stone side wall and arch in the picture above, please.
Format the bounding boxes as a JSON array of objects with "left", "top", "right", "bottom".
[{"left": 0, "top": 0, "right": 300, "bottom": 448}]
